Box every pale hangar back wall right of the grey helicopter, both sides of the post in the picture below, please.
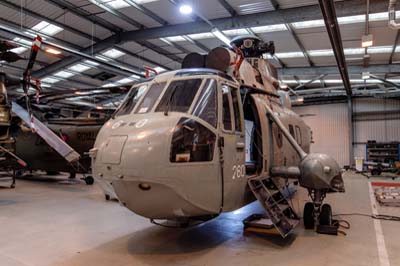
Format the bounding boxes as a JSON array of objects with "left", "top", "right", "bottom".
[{"left": 293, "top": 98, "right": 400, "bottom": 166}]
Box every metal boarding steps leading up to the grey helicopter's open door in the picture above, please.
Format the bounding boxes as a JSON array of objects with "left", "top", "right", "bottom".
[{"left": 245, "top": 177, "right": 300, "bottom": 237}]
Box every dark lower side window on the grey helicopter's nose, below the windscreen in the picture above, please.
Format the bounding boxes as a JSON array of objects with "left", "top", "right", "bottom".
[{"left": 170, "top": 118, "right": 216, "bottom": 163}]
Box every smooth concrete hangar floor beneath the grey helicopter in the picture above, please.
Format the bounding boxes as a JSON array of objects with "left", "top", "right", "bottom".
[{"left": 0, "top": 173, "right": 400, "bottom": 266}]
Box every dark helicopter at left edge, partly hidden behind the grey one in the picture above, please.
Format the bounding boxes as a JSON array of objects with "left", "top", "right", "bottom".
[{"left": 0, "top": 36, "right": 127, "bottom": 188}]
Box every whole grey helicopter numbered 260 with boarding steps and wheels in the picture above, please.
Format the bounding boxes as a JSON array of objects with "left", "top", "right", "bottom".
[{"left": 89, "top": 36, "right": 344, "bottom": 237}]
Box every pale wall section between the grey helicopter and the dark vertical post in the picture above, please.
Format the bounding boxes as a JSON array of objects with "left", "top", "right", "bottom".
[{"left": 293, "top": 103, "right": 349, "bottom": 166}]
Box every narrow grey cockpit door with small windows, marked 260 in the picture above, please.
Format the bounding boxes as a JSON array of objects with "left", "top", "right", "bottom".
[{"left": 219, "top": 83, "right": 246, "bottom": 211}]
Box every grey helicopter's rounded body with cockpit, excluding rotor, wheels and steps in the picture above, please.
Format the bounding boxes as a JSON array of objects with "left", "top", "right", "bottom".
[{"left": 91, "top": 69, "right": 311, "bottom": 219}]
